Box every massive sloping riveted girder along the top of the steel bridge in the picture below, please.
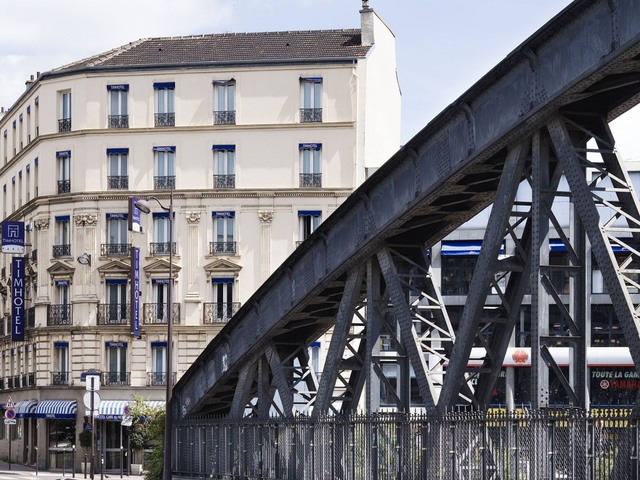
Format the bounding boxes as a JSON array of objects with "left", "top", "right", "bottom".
[{"left": 171, "top": 0, "right": 640, "bottom": 421}]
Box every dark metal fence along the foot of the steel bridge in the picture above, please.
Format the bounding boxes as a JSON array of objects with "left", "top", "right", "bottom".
[{"left": 173, "top": 409, "right": 640, "bottom": 480}]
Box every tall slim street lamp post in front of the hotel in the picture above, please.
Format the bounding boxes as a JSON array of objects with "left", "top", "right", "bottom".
[{"left": 135, "top": 182, "right": 173, "bottom": 480}]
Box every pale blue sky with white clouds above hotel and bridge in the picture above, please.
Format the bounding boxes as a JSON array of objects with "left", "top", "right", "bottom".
[{"left": 0, "top": 0, "right": 640, "bottom": 159}]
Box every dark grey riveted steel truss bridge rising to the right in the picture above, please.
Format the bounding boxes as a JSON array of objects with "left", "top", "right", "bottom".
[{"left": 169, "top": 0, "right": 640, "bottom": 476}]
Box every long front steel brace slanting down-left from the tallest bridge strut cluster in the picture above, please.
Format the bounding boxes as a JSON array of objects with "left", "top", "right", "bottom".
[{"left": 438, "top": 143, "right": 529, "bottom": 411}]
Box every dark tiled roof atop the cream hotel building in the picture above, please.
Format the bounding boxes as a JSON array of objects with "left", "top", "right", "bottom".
[{"left": 53, "top": 29, "right": 370, "bottom": 73}]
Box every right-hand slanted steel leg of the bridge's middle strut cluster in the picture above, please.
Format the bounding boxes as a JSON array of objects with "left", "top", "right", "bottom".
[{"left": 377, "top": 248, "right": 435, "bottom": 408}]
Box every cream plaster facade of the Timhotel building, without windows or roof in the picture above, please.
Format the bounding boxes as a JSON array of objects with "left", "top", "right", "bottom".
[{"left": 0, "top": 8, "right": 400, "bottom": 469}]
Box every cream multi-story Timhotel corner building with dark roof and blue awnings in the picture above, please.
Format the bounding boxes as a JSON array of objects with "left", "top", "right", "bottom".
[{"left": 0, "top": 6, "right": 400, "bottom": 471}]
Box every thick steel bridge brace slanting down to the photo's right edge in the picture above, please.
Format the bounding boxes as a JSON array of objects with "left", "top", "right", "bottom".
[{"left": 547, "top": 118, "right": 640, "bottom": 368}]
